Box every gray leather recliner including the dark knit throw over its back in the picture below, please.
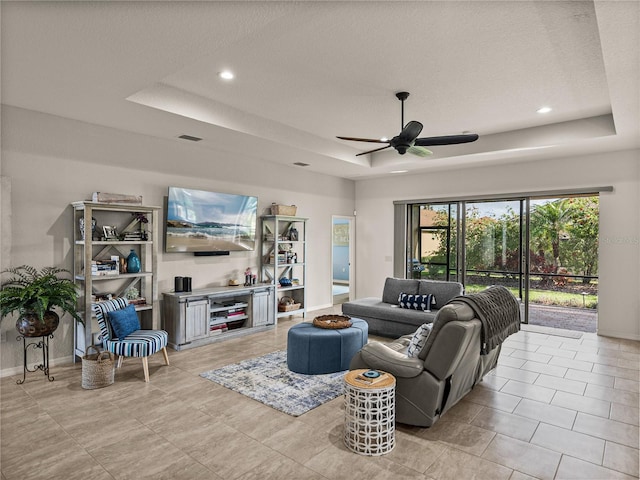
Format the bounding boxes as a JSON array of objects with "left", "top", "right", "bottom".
[{"left": 349, "top": 287, "right": 520, "bottom": 427}]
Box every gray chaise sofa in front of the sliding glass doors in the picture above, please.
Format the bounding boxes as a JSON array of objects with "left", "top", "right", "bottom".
[{"left": 342, "top": 278, "right": 463, "bottom": 338}]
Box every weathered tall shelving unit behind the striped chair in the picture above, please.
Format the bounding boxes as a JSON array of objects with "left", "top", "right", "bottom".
[{"left": 71, "top": 201, "right": 160, "bottom": 357}]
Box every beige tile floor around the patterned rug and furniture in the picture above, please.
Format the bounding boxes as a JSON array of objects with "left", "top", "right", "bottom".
[{"left": 0, "top": 312, "right": 640, "bottom": 480}]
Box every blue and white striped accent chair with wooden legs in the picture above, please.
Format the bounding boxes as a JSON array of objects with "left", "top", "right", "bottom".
[{"left": 91, "top": 298, "right": 169, "bottom": 382}]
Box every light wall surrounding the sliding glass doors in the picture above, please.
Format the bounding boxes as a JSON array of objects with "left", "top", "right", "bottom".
[{"left": 356, "top": 150, "right": 640, "bottom": 340}]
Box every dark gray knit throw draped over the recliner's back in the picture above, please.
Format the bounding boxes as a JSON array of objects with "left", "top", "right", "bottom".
[{"left": 451, "top": 285, "right": 520, "bottom": 355}]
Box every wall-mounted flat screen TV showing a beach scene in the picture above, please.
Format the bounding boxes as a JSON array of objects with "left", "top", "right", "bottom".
[{"left": 165, "top": 187, "right": 258, "bottom": 254}]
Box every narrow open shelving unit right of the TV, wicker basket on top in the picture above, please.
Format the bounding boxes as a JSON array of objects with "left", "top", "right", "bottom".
[{"left": 261, "top": 215, "right": 308, "bottom": 318}]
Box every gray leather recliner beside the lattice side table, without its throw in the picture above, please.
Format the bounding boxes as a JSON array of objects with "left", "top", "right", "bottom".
[{"left": 349, "top": 300, "right": 501, "bottom": 427}]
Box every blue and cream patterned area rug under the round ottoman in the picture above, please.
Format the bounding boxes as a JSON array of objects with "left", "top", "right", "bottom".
[{"left": 200, "top": 350, "right": 346, "bottom": 417}]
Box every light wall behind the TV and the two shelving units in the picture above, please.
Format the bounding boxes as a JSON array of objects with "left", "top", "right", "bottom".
[{"left": 0, "top": 106, "right": 355, "bottom": 375}]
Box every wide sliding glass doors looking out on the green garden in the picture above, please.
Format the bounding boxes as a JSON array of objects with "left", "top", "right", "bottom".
[{"left": 407, "top": 196, "right": 598, "bottom": 331}]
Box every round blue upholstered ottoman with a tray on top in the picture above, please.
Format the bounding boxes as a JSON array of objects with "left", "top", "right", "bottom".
[{"left": 287, "top": 318, "right": 369, "bottom": 375}]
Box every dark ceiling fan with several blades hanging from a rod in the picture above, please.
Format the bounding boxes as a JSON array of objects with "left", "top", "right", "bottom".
[{"left": 337, "top": 92, "right": 478, "bottom": 157}]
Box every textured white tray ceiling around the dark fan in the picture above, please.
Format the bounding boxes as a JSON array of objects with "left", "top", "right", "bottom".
[{"left": 0, "top": 1, "right": 640, "bottom": 179}]
